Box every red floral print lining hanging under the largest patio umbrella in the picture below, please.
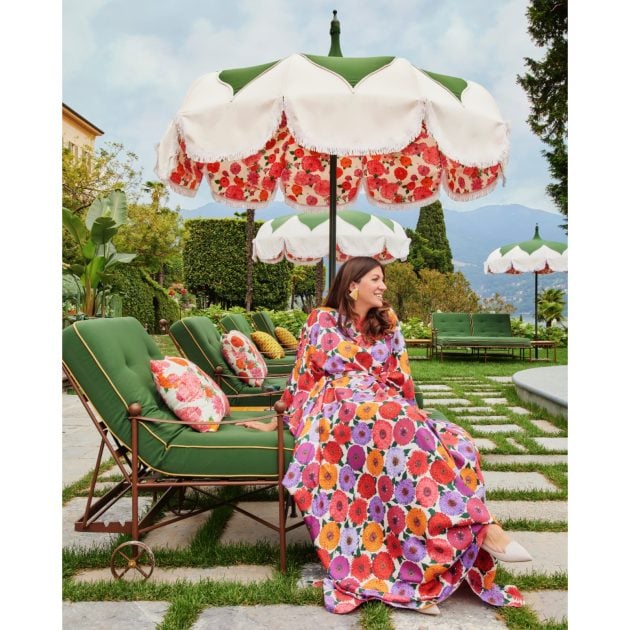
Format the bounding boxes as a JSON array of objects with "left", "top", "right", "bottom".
[{"left": 164, "top": 116, "right": 501, "bottom": 210}]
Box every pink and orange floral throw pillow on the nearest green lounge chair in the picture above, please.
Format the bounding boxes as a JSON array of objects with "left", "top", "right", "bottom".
[{"left": 150, "top": 357, "right": 230, "bottom": 433}]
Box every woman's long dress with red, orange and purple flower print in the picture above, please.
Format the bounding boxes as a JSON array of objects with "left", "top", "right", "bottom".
[{"left": 283, "top": 308, "right": 522, "bottom": 613}]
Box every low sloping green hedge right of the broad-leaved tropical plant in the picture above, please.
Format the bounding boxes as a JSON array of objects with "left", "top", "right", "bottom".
[{"left": 112, "top": 265, "right": 179, "bottom": 334}]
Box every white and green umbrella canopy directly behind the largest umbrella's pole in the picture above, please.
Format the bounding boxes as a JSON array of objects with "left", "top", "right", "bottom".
[{"left": 253, "top": 210, "right": 411, "bottom": 265}]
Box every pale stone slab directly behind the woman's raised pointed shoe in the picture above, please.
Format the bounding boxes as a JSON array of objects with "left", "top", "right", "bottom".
[{"left": 499, "top": 531, "right": 568, "bottom": 575}]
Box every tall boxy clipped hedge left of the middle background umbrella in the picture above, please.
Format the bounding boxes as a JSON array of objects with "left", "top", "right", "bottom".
[{"left": 184, "top": 219, "right": 290, "bottom": 309}]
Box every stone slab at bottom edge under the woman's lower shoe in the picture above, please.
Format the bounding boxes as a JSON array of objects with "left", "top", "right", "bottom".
[{"left": 391, "top": 585, "right": 507, "bottom": 630}]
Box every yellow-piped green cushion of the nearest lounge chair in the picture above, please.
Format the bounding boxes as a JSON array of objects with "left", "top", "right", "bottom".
[{"left": 62, "top": 317, "right": 293, "bottom": 478}]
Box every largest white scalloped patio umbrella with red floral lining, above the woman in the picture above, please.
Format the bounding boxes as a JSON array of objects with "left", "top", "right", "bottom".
[{"left": 155, "top": 12, "right": 508, "bottom": 286}]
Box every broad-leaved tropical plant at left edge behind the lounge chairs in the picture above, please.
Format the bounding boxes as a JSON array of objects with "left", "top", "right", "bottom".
[{"left": 63, "top": 190, "right": 136, "bottom": 317}]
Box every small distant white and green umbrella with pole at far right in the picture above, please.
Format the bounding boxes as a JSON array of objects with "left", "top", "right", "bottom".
[{"left": 483, "top": 224, "right": 569, "bottom": 358}]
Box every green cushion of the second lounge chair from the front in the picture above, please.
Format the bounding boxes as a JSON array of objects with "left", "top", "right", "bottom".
[{"left": 169, "top": 316, "right": 287, "bottom": 406}]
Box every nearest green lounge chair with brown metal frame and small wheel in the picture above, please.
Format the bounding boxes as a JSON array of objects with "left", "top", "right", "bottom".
[{"left": 62, "top": 317, "right": 301, "bottom": 579}]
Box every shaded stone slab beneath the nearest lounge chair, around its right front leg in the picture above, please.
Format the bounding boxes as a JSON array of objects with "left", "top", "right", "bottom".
[{"left": 220, "top": 501, "right": 312, "bottom": 545}]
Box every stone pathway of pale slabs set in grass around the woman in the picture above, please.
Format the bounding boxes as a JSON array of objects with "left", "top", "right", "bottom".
[{"left": 62, "top": 376, "right": 568, "bottom": 630}]
